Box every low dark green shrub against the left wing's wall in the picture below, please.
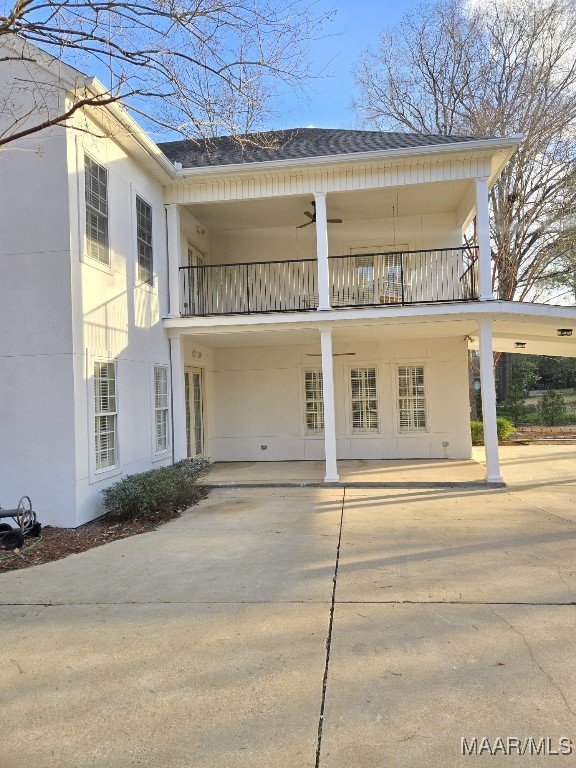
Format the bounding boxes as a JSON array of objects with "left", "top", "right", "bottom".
[{"left": 102, "top": 459, "right": 210, "bottom": 520}]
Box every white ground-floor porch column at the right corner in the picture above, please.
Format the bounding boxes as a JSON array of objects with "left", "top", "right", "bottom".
[{"left": 479, "top": 320, "right": 502, "bottom": 483}]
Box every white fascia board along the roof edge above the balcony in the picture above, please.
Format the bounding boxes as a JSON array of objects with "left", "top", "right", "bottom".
[{"left": 176, "top": 135, "right": 522, "bottom": 179}]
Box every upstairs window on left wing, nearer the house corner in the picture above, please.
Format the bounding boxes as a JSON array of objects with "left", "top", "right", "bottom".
[{"left": 84, "top": 155, "right": 110, "bottom": 265}]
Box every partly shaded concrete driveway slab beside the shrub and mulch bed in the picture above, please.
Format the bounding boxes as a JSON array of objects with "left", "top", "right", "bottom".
[{"left": 0, "top": 489, "right": 342, "bottom": 604}]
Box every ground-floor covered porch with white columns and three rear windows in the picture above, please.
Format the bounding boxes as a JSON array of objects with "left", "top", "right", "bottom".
[{"left": 169, "top": 302, "right": 576, "bottom": 486}]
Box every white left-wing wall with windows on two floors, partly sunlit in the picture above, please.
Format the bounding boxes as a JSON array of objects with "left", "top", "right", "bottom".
[{"left": 68, "top": 120, "right": 172, "bottom": 525}]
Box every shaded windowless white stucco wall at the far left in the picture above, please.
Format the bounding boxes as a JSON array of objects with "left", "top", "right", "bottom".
[{"left": 0, "top": 88, "right": 75, "bottom": 525}]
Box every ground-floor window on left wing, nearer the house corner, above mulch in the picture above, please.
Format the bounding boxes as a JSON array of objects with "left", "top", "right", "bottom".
[{"left": 94, "top": 360, "right": 118, "bottom": 470}]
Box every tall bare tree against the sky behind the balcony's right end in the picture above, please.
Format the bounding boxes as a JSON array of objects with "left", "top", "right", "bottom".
[{"left": 354, "top": 0, "right": 576, "bottom": 300}]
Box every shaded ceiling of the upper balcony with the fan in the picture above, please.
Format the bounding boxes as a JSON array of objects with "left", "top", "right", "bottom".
[{"left": 187, "top": 181, "right": 470, "bottom": 230}]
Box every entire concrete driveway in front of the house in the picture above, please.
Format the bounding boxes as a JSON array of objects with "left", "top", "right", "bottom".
[{"left": 0, "top": 446, "right": 576, "bottom": 768}]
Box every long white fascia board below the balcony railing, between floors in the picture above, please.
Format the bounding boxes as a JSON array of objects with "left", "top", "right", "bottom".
[{"left": 163, "top": 300, "right": 576, "bottom": 335}]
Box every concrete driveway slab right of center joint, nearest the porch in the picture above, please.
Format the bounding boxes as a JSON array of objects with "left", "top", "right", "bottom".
[{"left": 338, "top": 490, "right": 576, "bottom": 603}]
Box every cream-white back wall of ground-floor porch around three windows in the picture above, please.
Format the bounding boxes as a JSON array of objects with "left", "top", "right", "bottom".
[{"left": 207, "top": 339, "right": 471, "bottom": 461}]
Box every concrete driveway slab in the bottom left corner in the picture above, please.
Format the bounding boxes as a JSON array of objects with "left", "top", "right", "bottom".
[{"left": 0, "top": 604, "right": 328, "bottom": 768}]
